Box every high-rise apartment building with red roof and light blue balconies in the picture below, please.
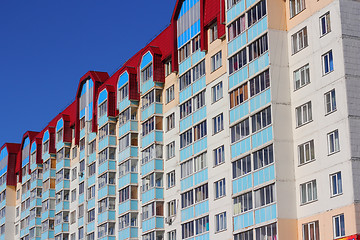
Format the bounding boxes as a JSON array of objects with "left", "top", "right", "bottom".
[{"left": 0, "top": 0, "right": 360, "bottom": 240}]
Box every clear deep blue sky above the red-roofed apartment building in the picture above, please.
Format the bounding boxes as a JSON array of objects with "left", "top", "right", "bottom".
[{"left": 0, "top": 0, "right": 176, "bottom": 147}]
